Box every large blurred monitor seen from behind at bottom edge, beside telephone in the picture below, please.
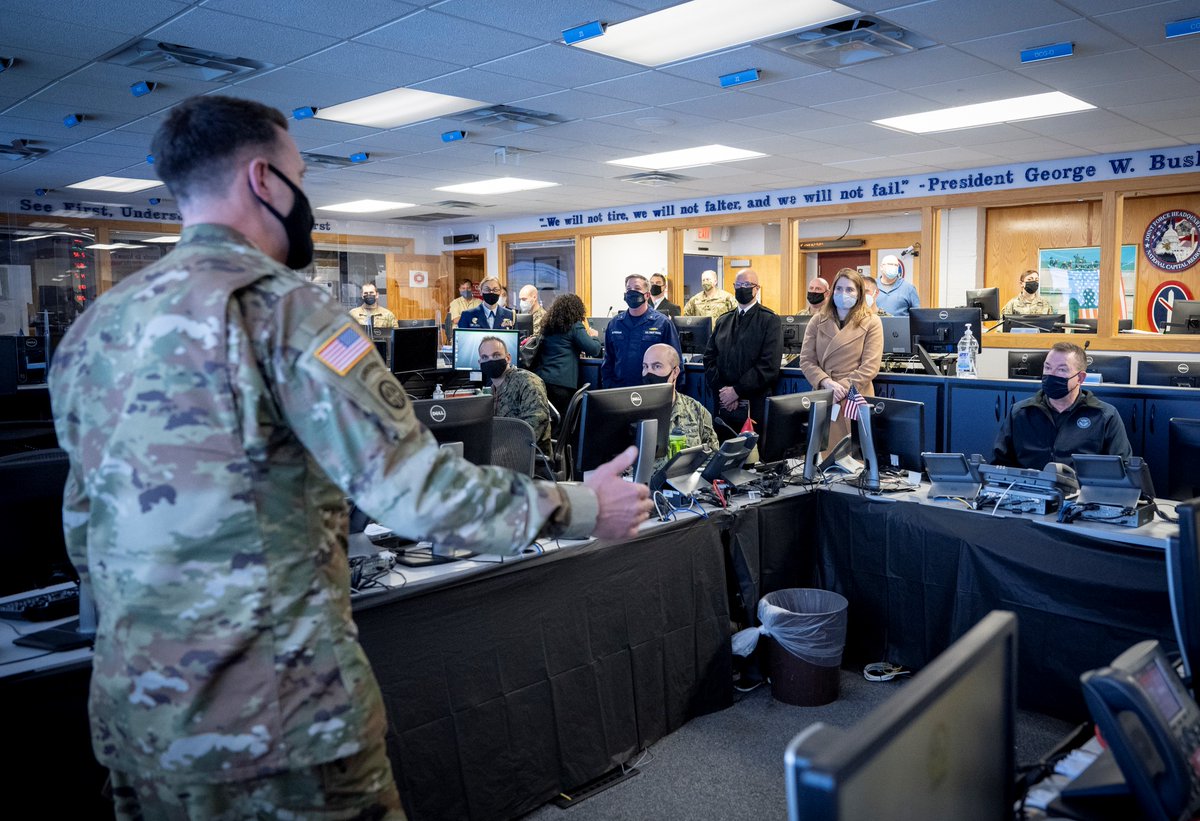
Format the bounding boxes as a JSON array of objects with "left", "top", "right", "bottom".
[{"left": 785, "top": 611, "right": 1016, "bottom": 821}]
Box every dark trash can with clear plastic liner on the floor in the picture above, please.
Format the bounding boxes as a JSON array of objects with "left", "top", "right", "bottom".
[{"left": 758, "top": 588, "right": 848, "bottom": 707}]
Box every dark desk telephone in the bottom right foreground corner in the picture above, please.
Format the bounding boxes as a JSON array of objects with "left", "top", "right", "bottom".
[{"left": 1080, "top": 641, "right": 1200, "bottom": 821}]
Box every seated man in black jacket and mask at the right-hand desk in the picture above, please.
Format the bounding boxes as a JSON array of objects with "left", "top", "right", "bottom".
[{"left": 991, "top": 342, "right": 1133, "bottom": 471}]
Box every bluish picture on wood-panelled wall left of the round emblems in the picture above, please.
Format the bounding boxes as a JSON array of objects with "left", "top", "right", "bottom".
[{"left": 1038, "top": 245, "right": 1138, "bottom": 322}]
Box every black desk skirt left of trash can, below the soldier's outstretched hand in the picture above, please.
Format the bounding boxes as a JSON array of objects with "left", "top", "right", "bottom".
[{"left": 354, "top": 520, "right": 732, "bottom": 821}]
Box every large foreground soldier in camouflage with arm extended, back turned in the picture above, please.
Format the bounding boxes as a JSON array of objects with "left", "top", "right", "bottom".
[{"left": 50, "top": 96, "right": 650, "bottom": 819}]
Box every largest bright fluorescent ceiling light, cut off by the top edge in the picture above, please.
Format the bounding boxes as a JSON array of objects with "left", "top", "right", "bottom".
[{"left": 568, "top": 0, "right": 858, "bottom": 66}]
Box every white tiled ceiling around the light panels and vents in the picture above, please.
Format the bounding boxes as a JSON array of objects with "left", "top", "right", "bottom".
[{"left": 0, "top": 0, "right": 1200, "bottom": 221}]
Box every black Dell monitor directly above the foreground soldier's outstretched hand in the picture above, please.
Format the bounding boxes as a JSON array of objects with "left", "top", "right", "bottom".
[{"left": 576, "top": 385, "right": 674, "bottom": 475}]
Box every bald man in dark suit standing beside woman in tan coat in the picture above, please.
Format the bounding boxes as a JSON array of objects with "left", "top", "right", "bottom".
[{"left": 704, "top": 268, "right": 784, "bottom": 431}]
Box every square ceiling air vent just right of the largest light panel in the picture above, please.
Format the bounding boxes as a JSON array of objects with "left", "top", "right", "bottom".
[{"left": 762, "top": 16, "right": 934, "bottom": 68}]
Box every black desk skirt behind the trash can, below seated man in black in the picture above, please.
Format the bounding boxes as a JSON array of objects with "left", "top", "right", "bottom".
[{"left": 761, "top": 492, "right": 1175, "bottom": 720}]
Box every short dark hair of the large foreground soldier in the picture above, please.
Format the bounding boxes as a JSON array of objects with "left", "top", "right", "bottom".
[{"left": 150, "top": 95, "right": 288, "bottom": 200}]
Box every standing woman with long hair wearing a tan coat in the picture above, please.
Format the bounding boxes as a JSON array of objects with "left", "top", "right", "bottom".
[{"left": 800, "top": 268, "right": 883, "bottom": 447}]
